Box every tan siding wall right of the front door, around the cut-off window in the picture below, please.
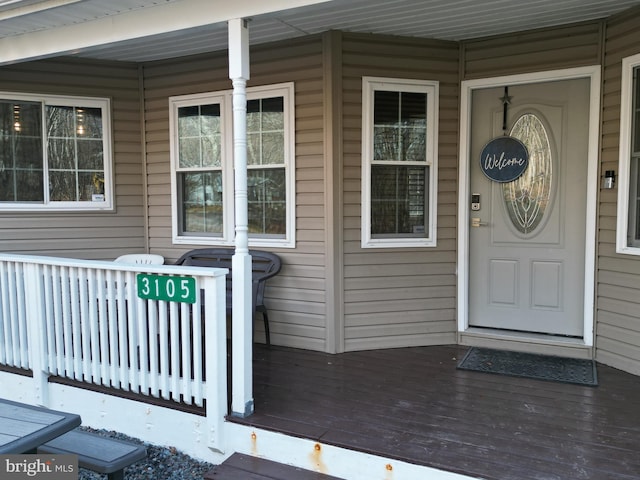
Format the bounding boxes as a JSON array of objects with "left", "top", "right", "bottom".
[{"left": 596, "top": 9, "right": 640, "bottom": 374}]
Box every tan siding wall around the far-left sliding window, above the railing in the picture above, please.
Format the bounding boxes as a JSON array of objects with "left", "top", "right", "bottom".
[{"left": 0, "top": 58, "right": 146, "bottom": 260}]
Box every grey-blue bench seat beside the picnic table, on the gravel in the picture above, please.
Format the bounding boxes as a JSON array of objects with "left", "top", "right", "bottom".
[{"left": 38, "top": 430, "right": 147, "bottom": 480}]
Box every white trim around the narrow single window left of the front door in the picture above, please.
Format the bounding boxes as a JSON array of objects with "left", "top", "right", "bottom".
[{"left": 361, "top": 77, "right": 439, "bottom": 248}]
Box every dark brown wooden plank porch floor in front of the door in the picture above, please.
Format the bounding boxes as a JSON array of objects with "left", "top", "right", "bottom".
[{"left": 228, "top": 346, "right": 640, "bottom": 480}]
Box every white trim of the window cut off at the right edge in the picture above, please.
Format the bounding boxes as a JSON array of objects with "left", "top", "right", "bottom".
[{"left": 616, "top": 54, "right": 640, "bottom": 255}]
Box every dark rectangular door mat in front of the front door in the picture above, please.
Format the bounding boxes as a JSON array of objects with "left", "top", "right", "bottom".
[{"left": 458, "top": 347, "right": 598, "bottom": 387}]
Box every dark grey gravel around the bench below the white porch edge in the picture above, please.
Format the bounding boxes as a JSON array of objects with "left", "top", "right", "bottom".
[{"left": 78, "top": 427, "right": 213, "bottom": 480}]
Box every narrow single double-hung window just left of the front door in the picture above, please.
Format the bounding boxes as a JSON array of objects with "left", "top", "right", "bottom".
[{"left": 362, "top": 77, "right": 438, "bottom": 247}]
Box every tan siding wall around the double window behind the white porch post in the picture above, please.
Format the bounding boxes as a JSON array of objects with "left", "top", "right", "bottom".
[{"left": 144, "top": 36, "right": 332, "bottom": 350}]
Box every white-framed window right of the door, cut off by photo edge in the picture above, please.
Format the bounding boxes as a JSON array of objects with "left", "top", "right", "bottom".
[{"left": 616, "top": 55, "right": 640, "bottom": 255}]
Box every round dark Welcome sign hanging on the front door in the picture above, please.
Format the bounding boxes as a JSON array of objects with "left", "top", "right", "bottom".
[{"left": 480, "top": 135, "right": 529, "bottom": 183}]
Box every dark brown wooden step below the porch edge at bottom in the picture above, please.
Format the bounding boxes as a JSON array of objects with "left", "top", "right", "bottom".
[{"left": 203, "top": 453, "right": 342, "bottom": 480}]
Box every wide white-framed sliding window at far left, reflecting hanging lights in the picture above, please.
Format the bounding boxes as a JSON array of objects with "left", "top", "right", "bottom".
[{"left": 0, "top": 93, "right": 112, "bottom": 211}]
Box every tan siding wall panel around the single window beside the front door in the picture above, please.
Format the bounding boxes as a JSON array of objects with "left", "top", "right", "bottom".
[{"left": 342, "top": 34, "right": 458, "bottom": 350}]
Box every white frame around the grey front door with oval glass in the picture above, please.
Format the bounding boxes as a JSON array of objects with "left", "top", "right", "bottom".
[{"left": 457, "top": 65, "right": 601, "bottom": 347}]
